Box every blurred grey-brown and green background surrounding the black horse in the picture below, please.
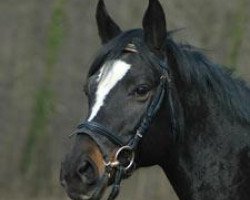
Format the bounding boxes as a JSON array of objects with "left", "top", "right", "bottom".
[{"left": 0, "top": 0, "right": 250, "bottom": 200}]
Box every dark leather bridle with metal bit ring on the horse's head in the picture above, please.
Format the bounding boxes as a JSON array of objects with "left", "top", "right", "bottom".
[{"left": 75, "top": 44, "right": 171, "bottom": 200}]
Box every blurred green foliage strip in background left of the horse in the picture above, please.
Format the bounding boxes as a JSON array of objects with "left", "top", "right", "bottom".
[{"left": 20, "top": 0, "right": 65, "bottom": 184}]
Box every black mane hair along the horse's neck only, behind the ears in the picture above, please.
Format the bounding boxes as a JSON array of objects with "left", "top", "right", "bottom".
[{"left": 166, "top": 38, "right": 250, "bottom": 124}]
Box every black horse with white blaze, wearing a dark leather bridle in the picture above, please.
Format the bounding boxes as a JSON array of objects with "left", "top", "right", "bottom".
[{"left": 60, "top": 0, "right": 250, "bottom": 200}]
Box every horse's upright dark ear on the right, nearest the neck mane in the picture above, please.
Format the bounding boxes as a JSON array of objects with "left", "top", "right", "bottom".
[{"left": 142, "top": 0, "right": 167, "bottom": 52}]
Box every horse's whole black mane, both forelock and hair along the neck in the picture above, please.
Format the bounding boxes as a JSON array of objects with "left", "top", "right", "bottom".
[{"left": 88, "top": 29, "right": 250, "bottom": 124}]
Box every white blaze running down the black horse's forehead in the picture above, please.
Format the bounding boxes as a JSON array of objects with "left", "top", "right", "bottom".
[{"left": 88, "top": 60, "right": 131, "bottom": 121}]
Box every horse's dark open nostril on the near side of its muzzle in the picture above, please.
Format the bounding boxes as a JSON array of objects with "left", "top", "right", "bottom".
[{"left": 77, "top": 160, "right": 96, "bottom": 185}]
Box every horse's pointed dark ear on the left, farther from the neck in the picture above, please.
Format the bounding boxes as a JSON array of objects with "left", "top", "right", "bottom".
[{"left": 96, "top": 0, "right": 122, "bottom": 44}]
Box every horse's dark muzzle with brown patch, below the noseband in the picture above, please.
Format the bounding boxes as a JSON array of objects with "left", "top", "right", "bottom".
[{"left": 60, "top": 135, "right": 105, "bottom": 200}]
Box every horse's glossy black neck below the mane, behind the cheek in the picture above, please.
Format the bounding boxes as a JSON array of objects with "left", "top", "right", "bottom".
[{"left": 162, "top": 89, "right": 250, "bottom": 200}]
